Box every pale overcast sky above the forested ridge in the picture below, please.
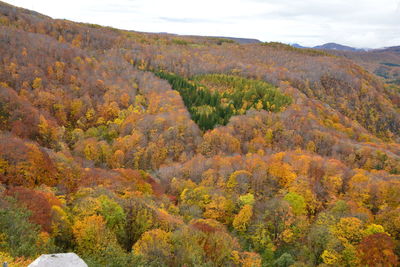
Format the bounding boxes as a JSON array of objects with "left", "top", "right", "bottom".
[{"left": 5, "top": 0, "right": 400, "bottom": 48}]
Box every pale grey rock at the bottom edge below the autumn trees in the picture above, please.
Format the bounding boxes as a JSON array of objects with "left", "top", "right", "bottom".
[{"left": 28, "top": 253, "right": 88, "bottom": 267}]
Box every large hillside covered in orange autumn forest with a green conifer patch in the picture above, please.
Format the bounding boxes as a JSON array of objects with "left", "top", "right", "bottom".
[{"left": 0, "top": 2, "right": 400, "bottom": 266}]
